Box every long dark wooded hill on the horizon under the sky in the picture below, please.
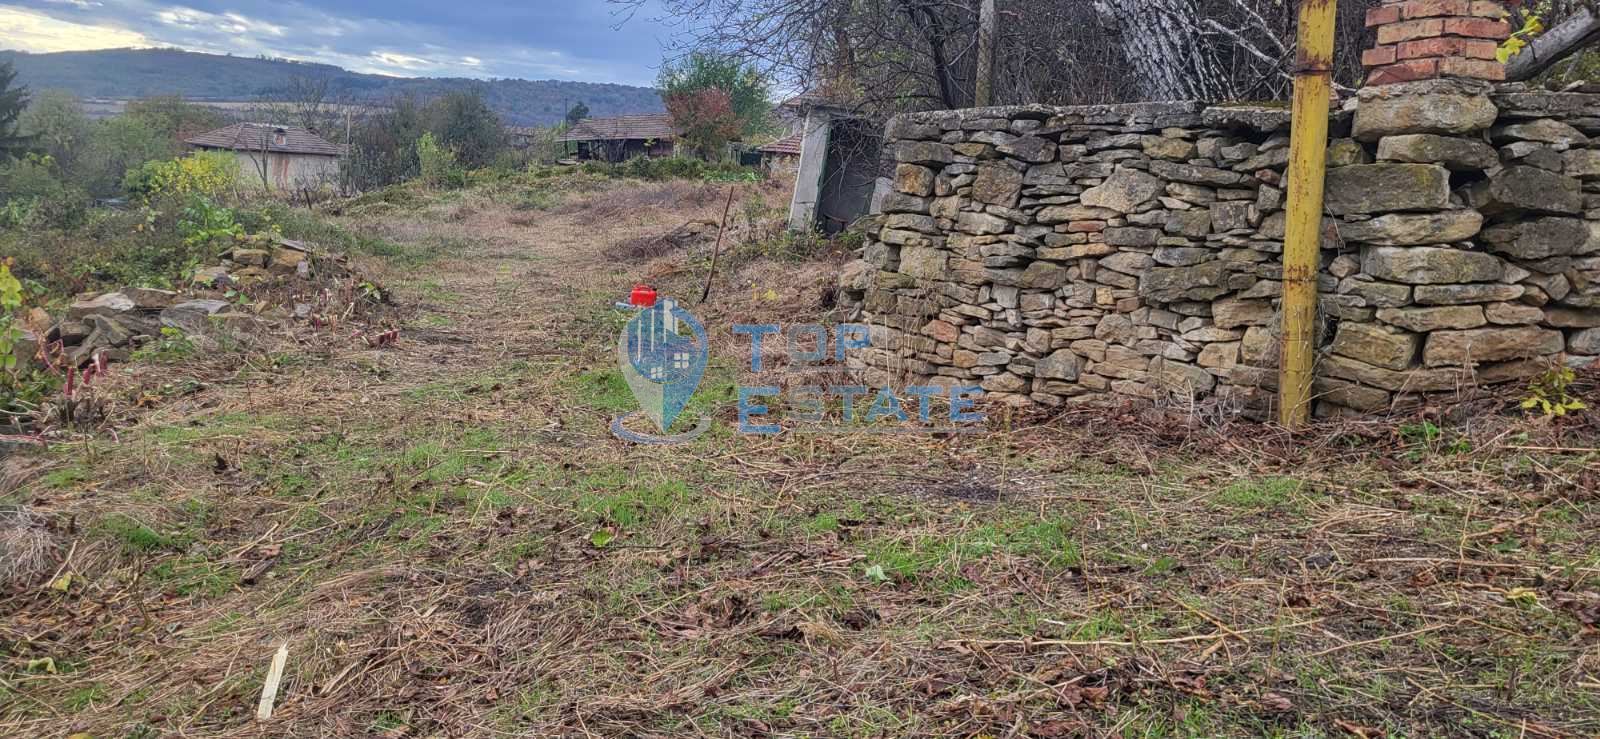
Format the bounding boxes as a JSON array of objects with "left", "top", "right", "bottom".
[{"left": 0, "top": 50, "right": 664, "bottom": 126}]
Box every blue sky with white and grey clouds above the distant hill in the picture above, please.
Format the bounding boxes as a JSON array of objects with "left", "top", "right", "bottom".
[{"left": 0, "top": 0, "right": 670, "bottom": 85}]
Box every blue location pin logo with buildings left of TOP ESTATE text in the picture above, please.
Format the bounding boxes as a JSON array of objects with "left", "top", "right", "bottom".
[{"left": 611, "top": 298, "right": 710, "bottom": 443}]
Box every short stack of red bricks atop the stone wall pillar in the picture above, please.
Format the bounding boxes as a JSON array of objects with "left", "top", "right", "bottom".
[{"left": 1362, "top": 0, "right": 1522, "bottom": 86}]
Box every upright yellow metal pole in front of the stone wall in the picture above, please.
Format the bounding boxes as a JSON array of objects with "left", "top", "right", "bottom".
[{"left": 1278, "top": 0, "right": 1338, "bottom": 429}]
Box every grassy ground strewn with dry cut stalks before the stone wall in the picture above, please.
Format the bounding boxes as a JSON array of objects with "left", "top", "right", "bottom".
[{"left": 0, "top": 174, "right": 1600, "bottom": 737}]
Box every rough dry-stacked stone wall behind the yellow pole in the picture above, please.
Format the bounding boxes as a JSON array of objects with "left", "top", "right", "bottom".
[{"left": 842, "top": 80, "right": 1600, "bottom": 416}]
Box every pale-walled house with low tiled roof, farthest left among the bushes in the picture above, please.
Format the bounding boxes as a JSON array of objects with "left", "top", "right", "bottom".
[{"left": 186, "top": 123, "right": 344, "bottom": 192}]
